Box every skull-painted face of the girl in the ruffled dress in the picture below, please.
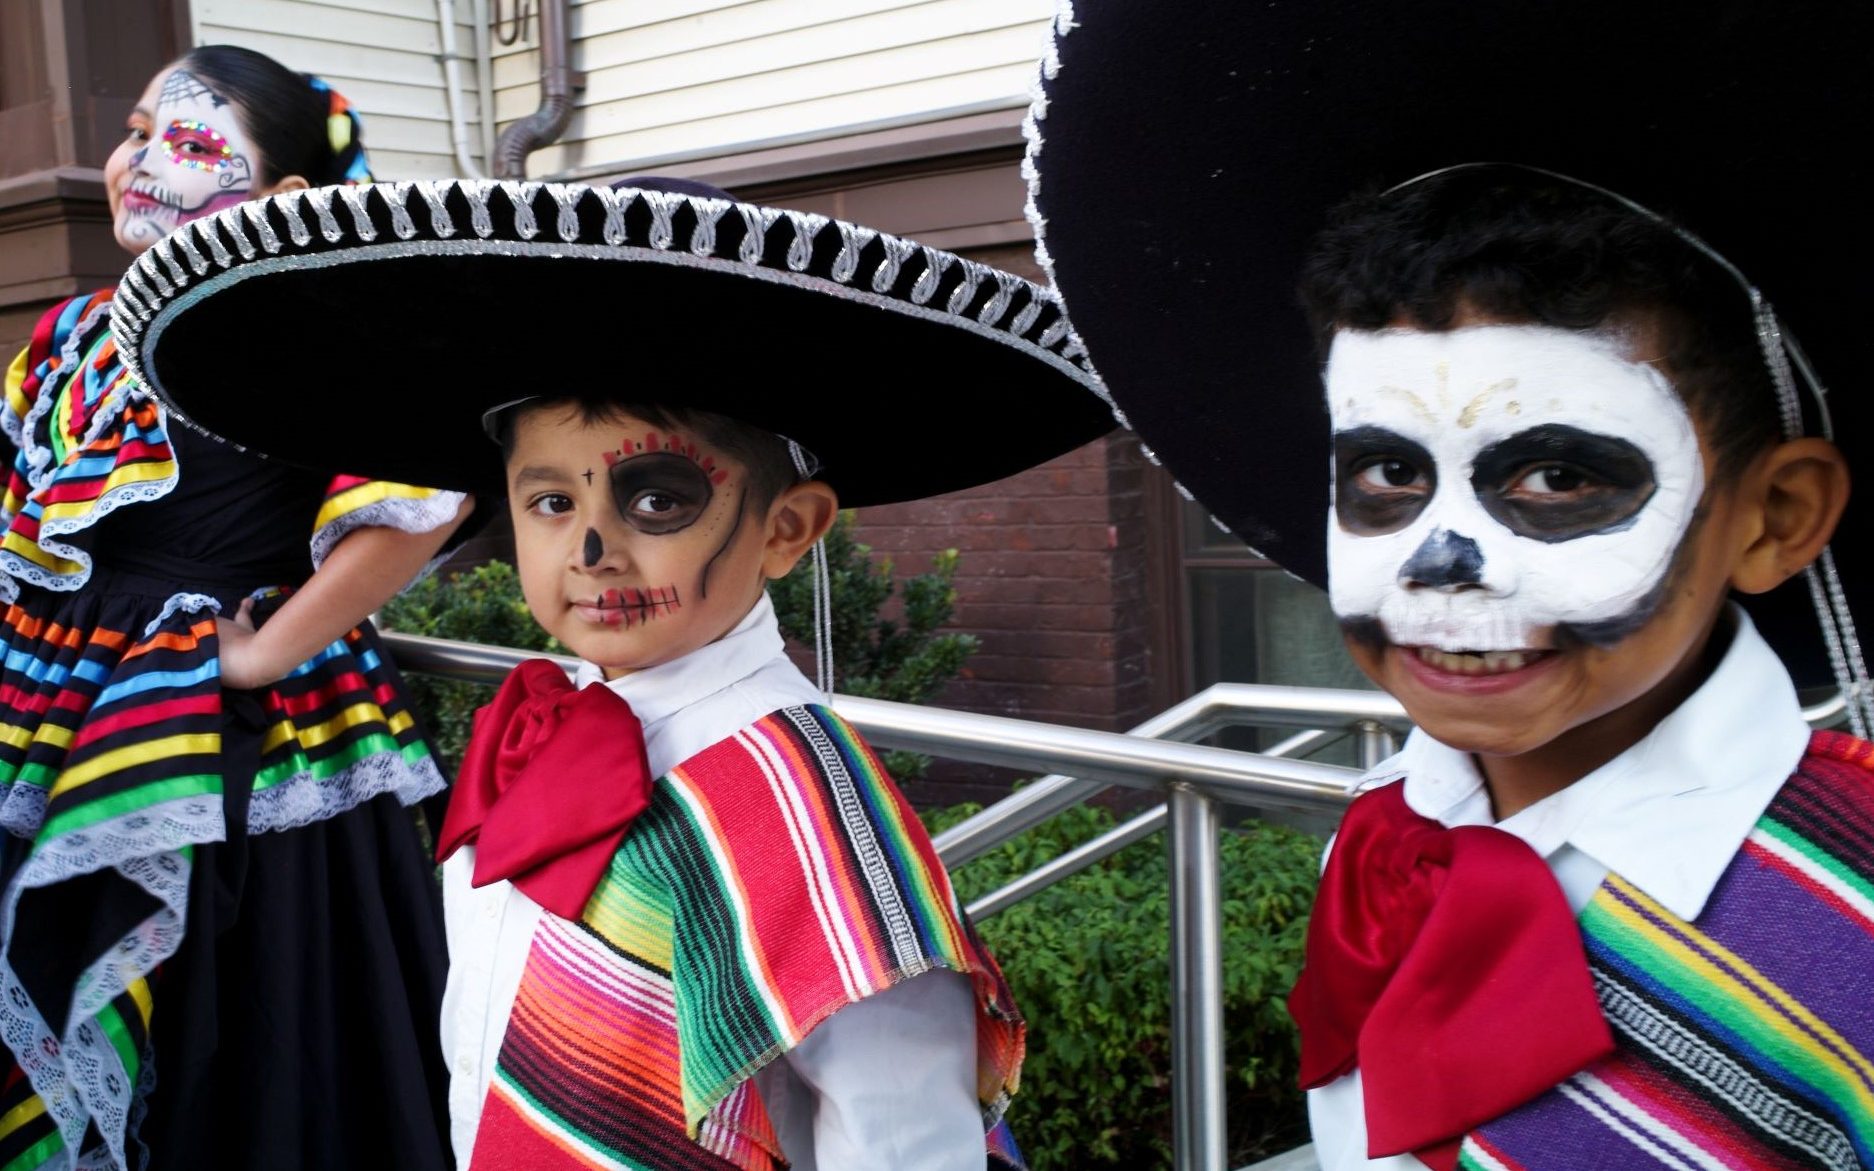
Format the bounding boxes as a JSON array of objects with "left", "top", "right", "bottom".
[{"left": 105, "top": 67, "right": 259, "bottom": 251}]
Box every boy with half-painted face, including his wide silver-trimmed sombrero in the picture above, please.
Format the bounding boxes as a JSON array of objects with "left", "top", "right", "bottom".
[{"left": 116, "top": 180, "right": 1109, "bottom": 1171}]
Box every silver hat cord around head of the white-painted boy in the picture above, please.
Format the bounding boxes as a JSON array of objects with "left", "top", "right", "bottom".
[{"left": 1387, "top": 163, "right": 1874, "bottom": 740}]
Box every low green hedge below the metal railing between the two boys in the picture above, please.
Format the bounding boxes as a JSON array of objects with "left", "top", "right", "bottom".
[{"left": 926, "top": 806, "right": 1321, "bottom": 1171}]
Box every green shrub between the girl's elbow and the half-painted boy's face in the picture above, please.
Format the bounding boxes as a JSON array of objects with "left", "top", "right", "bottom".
[{"left": 377, "top": 560, "right": 566, "bottom": 774}]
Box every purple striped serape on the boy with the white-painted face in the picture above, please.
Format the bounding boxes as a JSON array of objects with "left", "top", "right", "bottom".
[{"left": 1458, "top": 733, "right": 1874, "bottom": 1171}]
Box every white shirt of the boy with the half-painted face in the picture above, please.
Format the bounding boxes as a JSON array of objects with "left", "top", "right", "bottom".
[{"left": 442, "top": 594, "right": 984, "bottom": 1171}]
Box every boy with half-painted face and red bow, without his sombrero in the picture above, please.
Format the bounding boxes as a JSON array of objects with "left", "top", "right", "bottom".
[{"left": 427, "top": 214, "right": 1056, "bottom": 1171}]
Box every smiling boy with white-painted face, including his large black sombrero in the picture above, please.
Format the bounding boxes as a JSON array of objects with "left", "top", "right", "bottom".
[{"left": 1031, "top": 0, "right": 1874, "bottom": 1171}]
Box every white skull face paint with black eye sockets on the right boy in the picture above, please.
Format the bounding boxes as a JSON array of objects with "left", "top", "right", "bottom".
[{"left": 1327, "top": 324, "right": 1705, "bottom": 652}]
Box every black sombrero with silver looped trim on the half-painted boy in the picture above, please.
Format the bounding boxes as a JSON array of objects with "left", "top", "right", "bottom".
[{"left": 112, "top": 182, "right": 1111, "bottom": 506}]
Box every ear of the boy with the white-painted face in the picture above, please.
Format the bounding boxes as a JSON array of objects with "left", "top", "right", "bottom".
[{"left": 1732, "top": 438, "right": 1848, "bottom": 594}]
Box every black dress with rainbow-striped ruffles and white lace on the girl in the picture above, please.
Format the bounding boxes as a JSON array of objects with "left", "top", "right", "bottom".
[{"left": 0, "top": 292, "right": 461, "bottom": 1171}]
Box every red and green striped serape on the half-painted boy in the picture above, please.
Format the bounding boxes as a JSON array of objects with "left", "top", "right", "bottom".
[{"left": 470, "top": 706, "right": 1023, "bottom": 1171}]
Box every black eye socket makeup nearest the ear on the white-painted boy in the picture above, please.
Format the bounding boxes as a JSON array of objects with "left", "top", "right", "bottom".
[{"left": 1471, "top": 423, "right": 1657, "bottom": 543}]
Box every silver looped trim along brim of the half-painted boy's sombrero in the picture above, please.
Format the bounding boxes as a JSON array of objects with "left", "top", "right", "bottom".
[{"left": 111, "top": 180, "right": 1109, "bottom": 445}]
